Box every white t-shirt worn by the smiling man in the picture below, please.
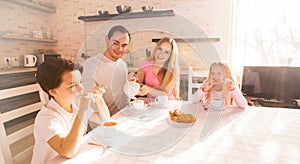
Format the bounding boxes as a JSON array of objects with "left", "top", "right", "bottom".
[{"left": 82, "top": 53, "right": 129, "bottom": 115}]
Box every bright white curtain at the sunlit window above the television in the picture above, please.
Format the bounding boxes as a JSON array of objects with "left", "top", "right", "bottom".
[{"left": 232, "top": 0, "right": 300, "bottom": 75}]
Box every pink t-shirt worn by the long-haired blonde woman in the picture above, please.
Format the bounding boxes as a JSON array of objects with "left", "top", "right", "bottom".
[{"left": 140, "top": 59, "right": 175, "bottom": 100}]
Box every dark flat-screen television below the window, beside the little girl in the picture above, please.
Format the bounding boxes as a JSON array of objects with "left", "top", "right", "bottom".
[{"left": 242, "top": 66, "right": 300, "bottom": 101}]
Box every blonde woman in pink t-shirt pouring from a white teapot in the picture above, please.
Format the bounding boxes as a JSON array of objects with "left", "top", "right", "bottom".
[{"left": 137, "top": 37, "right": 180, "bottom": 100}]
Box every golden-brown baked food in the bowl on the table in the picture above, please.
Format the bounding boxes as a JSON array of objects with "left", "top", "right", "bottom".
[{"left": 169, "top": 109, "right": 196, "bottom": 123}]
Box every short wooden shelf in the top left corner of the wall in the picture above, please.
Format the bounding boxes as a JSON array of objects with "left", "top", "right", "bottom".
[{"left": 4, "top": 0, "right": 56, "bottom": 13}]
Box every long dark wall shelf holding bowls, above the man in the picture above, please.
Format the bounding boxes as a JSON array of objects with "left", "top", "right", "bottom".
[{"left": 78, "top": 10, "right": 175, "bottom": 22}]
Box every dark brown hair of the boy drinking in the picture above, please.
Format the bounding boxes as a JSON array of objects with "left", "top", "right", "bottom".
[{"left": 36, "top": 58, "right": 83, "bottom": 97}]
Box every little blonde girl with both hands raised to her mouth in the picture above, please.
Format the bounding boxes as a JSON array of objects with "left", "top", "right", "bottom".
[{"left": 192, "top": 62, "right": 247, "bottom": 109}]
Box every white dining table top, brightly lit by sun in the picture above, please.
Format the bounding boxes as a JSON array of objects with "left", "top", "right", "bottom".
[{"left": 51, "top": 101, "right": 300, "bottom": 164}]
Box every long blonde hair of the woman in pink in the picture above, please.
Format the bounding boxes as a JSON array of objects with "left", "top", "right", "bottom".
[{"left": 149, "top": 37, "right": 179, "bottom": 98}]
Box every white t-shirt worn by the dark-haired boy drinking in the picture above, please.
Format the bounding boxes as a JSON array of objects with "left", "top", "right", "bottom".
[{"left": 31, "top": 99, "right": 76, "bottom": 164}]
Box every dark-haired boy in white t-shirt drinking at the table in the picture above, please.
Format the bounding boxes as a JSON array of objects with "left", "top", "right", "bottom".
[{"left": 32, "top": 59, "right": 105, "bottom": 163}]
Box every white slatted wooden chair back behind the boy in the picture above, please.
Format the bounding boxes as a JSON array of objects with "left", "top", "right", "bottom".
[{"left": 0, "top": 68, "right": 45, "bottom": 163}]
